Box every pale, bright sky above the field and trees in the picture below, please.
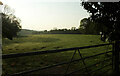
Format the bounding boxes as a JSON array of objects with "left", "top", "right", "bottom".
[{"left": 1, "top": 0, "right": 89, "bottom": 31}]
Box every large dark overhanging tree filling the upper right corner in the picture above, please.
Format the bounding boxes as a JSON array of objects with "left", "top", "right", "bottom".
[{"left": 82, "top": 2, "right": 120, "bottom": 41}]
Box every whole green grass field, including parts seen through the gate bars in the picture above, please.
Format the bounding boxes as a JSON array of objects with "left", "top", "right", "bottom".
[{"left": 2, "top": 34, "right": 111, "bottom": 75}]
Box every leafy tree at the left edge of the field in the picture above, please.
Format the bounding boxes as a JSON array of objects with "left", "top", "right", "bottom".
[{"left": 2, "top": 5, "right": 21, "bottom": 40}]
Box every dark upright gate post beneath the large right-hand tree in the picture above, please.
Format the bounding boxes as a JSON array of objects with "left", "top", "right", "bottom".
[{"left": 113, "top": 41, "right": 120, "bottom": 74}]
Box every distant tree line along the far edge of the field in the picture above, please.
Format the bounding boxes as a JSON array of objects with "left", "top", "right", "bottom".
[{"left": 33, "top": 18, "right": 101, "bottom": 35}]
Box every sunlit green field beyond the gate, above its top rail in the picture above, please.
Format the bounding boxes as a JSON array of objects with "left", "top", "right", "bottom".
[{"left": 3, "top": 34, "right": 103, "bottom": 53}]
